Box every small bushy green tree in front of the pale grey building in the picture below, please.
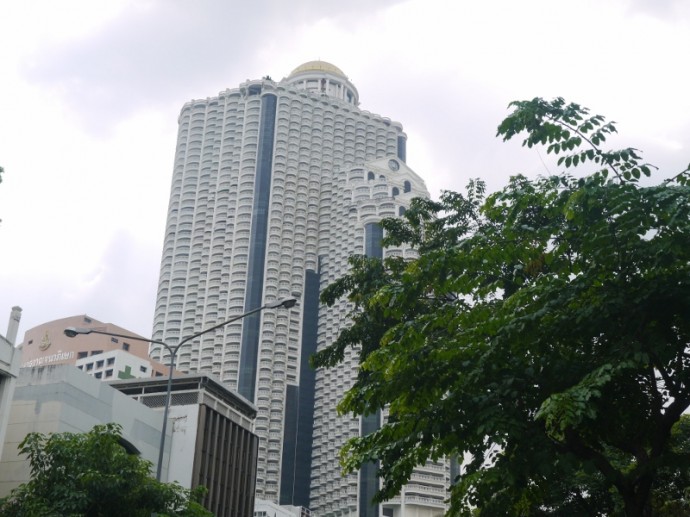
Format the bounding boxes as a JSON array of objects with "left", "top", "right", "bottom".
[{"left": 0, "top": 424, "right": 212, "bottom": 517}]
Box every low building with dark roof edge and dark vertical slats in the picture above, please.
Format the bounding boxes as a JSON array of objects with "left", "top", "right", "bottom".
[{"left": 110, "top": 375, "right": 258, "bottom": 517}]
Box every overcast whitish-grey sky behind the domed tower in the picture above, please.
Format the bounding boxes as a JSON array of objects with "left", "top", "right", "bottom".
[{"left": 0, "top": 0, "right": 690, "bottom": 341}]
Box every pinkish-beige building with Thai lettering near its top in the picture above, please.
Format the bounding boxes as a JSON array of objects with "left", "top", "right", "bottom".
[{"left": 20, "top": 314, "right": 168, "bottom": 380}]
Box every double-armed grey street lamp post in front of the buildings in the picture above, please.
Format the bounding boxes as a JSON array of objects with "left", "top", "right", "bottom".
[{"left": 64, "top": 297, "right": 297, "bottom": 481}]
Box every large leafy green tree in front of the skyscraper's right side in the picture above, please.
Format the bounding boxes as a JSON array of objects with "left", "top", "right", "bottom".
[{"left": 312, "top": 98, "right": 690, "bottom": 516}]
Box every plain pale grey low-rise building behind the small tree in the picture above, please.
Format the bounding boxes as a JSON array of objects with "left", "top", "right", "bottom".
[{"left": 0, "top": 364, "right": 165, "bottom": 497}]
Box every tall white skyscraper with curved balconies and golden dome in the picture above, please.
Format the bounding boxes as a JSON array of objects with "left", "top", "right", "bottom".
[{"left": 152, "top": 61, "right": 444, "bottom": 517}]
